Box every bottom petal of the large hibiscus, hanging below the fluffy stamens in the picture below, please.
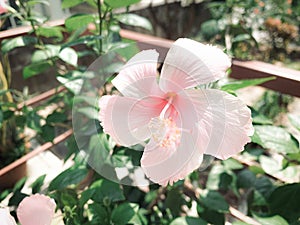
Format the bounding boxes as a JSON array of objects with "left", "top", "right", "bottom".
[{"left": 141, "top": 132, "right": 203, "bottom": 186}]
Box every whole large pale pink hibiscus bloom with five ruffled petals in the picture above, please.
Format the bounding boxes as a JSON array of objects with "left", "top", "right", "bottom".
[{"left": 99, "top": 38, "right": 254, "bottom": 185}]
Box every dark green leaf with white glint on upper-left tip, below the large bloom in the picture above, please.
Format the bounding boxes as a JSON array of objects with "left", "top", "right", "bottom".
[{"left": 200, "top": 190, "right": 229, "bottom": 213}]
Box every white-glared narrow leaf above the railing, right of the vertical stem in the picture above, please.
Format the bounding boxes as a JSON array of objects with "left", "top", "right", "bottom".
[{"left": 116, "top": 13, "right": 153, "bottom": 31}]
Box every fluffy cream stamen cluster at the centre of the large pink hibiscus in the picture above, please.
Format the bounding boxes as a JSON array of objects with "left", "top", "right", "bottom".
[{"left": 149, "top": 117, "right": 180, "bottom": 148}]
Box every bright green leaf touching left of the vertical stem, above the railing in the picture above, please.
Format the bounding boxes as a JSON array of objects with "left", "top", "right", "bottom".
[{"left": 65, "top": 14, "right": 95, "bottom": 31}]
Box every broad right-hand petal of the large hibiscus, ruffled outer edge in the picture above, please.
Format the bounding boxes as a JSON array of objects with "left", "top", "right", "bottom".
[{"left": 173, "top": 89, "right": 254, "bottom": 159}]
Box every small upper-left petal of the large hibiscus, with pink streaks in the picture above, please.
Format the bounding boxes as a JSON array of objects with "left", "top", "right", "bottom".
[{"left": 112, "top": 50, "right": 162, "bottom": 98}]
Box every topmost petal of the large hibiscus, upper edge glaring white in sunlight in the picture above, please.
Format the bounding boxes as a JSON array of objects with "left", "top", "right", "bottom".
[{"left": 159, "top": 38, "right": 231, "bottom": 92}]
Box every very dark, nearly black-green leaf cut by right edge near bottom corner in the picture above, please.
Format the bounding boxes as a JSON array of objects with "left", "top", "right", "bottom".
[{"left": 269, "top": 183, "right": 300, "bottom": 224}]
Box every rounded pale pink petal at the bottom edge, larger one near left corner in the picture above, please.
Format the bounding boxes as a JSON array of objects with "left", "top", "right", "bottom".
[{"left": 17, "top": 194, "right": 56, "bottom": 225}]
